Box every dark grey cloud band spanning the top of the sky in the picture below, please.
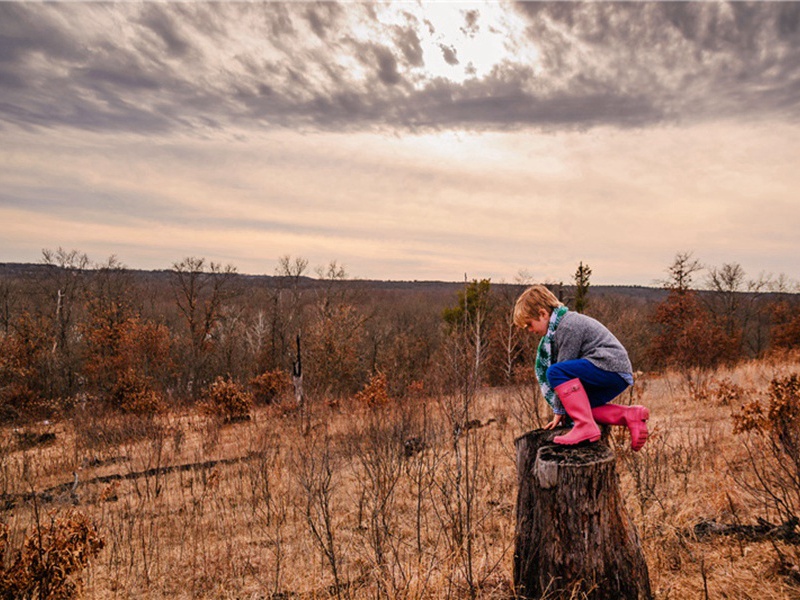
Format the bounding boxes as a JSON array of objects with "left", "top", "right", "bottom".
[{"left": 0, "top": 2, "right": 800, "bottom": 131}]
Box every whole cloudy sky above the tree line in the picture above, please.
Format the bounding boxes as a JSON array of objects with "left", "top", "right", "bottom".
[{"left": 0, "top": 1, "right": 800, "bottom": 285}]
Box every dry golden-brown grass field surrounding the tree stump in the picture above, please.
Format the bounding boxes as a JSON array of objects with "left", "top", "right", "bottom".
[{"left": 0, "top": 361, "right": 800, "bottom": 599}]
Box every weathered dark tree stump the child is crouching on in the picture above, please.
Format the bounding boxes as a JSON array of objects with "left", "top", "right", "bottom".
[{"left": 514, "top": 430, "right": 652, "bottom": 600}]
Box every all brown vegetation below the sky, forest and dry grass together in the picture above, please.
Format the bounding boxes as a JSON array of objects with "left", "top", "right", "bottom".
[{"left": 0, "top": 250, "right": 800, "bottom": 599}]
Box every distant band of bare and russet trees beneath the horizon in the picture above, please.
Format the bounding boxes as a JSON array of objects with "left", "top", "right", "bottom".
[{"left": 0, "top": 249, "right": 800, "bottom": 422}]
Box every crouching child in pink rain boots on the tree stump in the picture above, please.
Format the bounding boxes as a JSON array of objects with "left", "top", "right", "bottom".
[{"left": 514, "top": 285, "right": 650, "bottom": 451}]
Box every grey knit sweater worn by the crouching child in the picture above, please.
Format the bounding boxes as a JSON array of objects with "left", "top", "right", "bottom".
[{"left": 553, "top": 311, "right": 633, "bottom": 373}]
